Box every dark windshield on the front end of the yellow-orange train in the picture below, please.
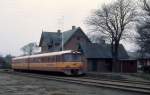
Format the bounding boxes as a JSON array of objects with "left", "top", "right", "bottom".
[{"left": 63, "top": 54, "right": 81, "bottom": 61}]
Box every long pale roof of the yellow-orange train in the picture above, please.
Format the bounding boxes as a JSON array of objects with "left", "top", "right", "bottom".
[{"left": 13, "top": 50, "right": 79, "bottom": 60}]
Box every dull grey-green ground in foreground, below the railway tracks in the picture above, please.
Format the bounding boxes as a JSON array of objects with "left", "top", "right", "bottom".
[{"left": 0, "top": 72, "right": 148, "bottom": 95}]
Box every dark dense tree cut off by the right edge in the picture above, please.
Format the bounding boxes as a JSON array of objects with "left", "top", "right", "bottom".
[{"left": 137, "top": 0, "right": 150, "bottom": 57}]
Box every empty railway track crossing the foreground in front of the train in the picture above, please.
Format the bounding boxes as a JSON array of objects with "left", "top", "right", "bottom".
[{"left": 1, "top": 71, "right": 150, "bottom": 95}]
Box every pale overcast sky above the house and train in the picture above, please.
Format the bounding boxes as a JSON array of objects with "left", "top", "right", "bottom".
[{"left": 0, "top": 0, "right": 136, "bottom": 55}]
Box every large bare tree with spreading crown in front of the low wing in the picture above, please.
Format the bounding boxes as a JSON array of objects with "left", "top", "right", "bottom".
[{"left": 87, "top": 0, "right": 137, "bottom": 60}]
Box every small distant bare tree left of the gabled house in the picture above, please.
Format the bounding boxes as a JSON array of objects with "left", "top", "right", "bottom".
[{"left": 21, "top": 42, "right": 38, "bottom": 55}]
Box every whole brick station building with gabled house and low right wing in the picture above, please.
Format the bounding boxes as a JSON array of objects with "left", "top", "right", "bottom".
[{"left": 39, "top": 26, "right": 137, "bottom": 72}]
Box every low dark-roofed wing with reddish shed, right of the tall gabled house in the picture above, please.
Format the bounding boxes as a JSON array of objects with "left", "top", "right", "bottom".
[{"left": 79, "top": 43, "right": 137, "bottom": 73}]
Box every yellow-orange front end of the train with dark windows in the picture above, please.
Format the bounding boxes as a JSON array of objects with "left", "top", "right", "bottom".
[{"left": 62, "top": 52, "right": 86, "bottom": 75}]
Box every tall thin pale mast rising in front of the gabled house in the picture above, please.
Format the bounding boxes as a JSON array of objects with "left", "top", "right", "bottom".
[{"left": 58, "top": 16, "right": 64, "bottom": 51}]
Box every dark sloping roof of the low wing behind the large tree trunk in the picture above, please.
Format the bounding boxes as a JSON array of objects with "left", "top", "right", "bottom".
[{"left": 80, "top": 43, "right": 128, "bottom": 59}]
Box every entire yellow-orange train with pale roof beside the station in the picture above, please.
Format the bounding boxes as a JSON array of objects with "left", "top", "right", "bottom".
[{"left": 12, "top": 50, "right": 86, "bottom": 75}]
